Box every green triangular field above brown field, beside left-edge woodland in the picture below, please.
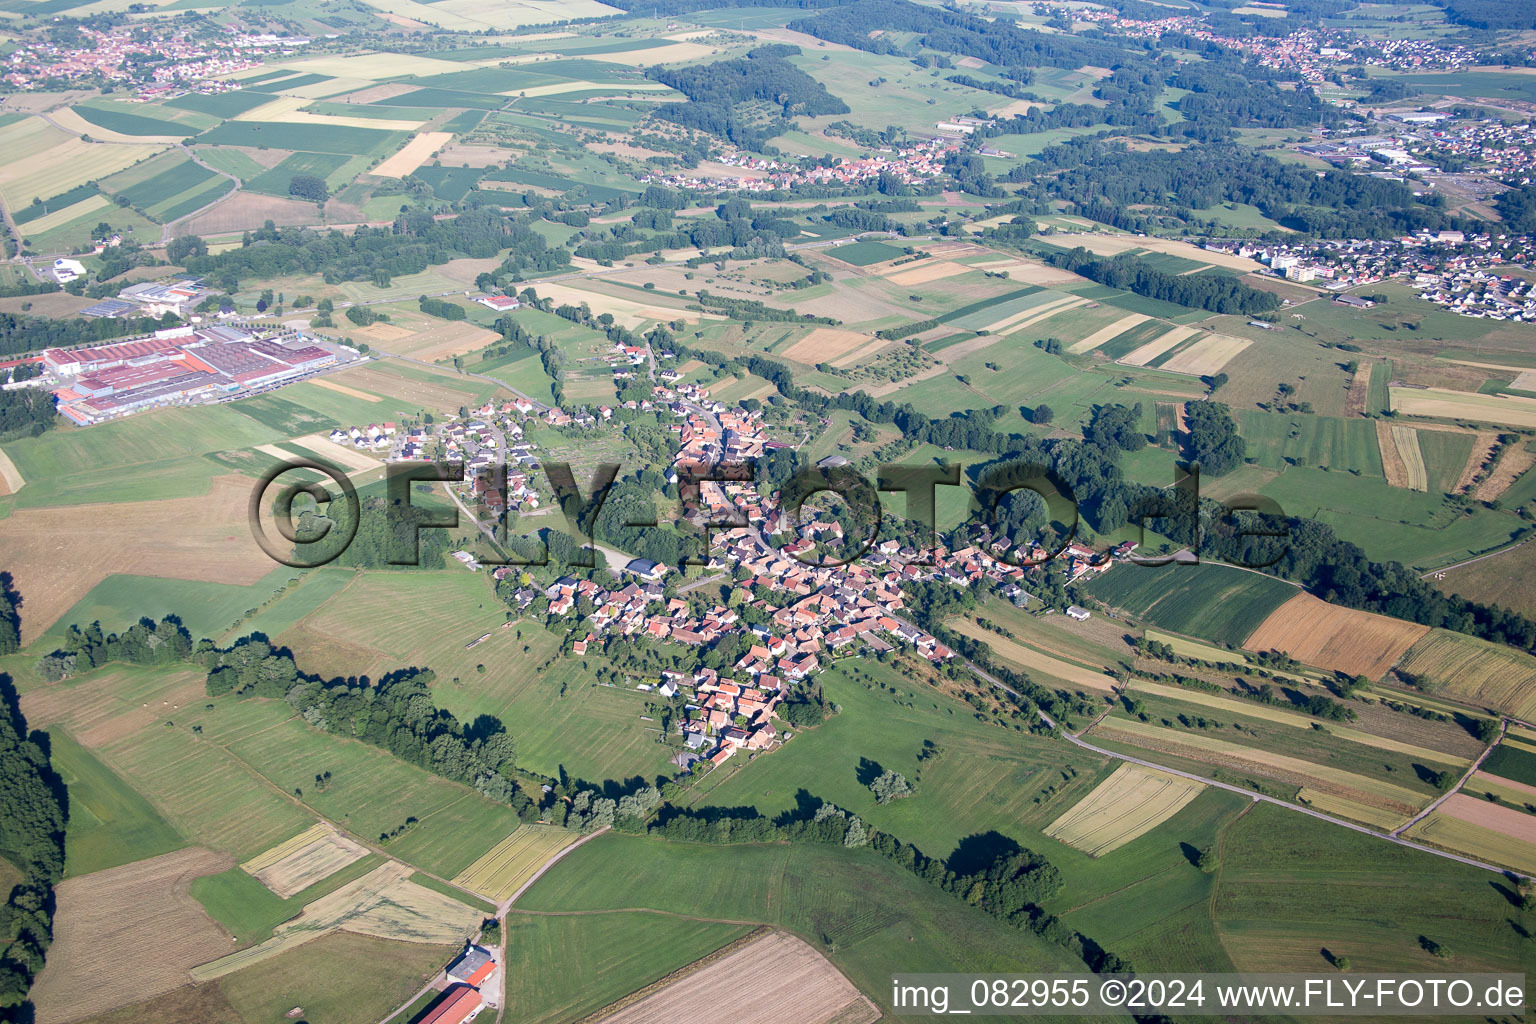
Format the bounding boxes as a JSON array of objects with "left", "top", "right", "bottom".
[{"left": 49, "top": 729, "right": 186, "bottom": 877}]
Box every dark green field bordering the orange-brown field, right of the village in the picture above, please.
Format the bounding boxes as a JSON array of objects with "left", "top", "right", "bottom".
[{"left": 1087, "top": 562, "right": 1301, "bottom": 645}]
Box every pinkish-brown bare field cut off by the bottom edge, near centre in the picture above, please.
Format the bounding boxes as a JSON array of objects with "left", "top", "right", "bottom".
[{"left": 604, "top": 932, "right": 880, "bottom": 1024}]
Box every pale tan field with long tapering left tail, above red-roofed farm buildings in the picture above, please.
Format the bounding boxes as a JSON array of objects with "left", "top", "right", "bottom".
[{"left": 190, "top": 861, "right": 481, "bottom": 981}]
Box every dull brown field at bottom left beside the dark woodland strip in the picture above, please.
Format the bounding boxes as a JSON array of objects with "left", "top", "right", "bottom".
[{"left": 31, "top": 847, "right": 229, "bottom": 1024}]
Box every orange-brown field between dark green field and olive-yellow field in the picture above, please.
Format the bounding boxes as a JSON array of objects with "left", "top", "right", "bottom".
[{"left": 1243, "top": 594, "right": 1430, "bottom": 679}]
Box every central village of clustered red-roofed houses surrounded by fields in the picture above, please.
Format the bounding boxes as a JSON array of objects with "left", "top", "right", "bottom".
[{"left": 330, "top": 345, "right": 1137, "bottom": 771}]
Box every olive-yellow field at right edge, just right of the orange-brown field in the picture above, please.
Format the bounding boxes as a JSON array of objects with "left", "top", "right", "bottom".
[{"left": 1399, "top": 629, "right": 1536, "bottom": 720}]
